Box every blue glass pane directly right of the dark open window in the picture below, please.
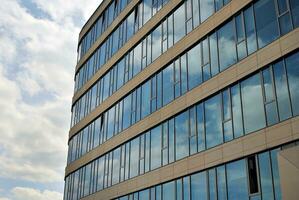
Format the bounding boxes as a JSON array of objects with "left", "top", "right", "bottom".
[{"left": 258, "top": 152, "right": 274, "bottom": 199}]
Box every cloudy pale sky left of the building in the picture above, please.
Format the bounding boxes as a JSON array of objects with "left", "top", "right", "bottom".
[{"left": 0, "top": 0, "right": 102, "bottom": 200}]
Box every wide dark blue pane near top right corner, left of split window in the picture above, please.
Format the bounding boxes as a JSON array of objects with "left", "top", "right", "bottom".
[{"left": 254, "top": 0, "right": 278, "bottom": 48}]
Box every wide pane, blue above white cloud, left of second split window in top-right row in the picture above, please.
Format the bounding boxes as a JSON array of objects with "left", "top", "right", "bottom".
[{"left": 218, "top": 21, "right": 237, "bottom": 71}]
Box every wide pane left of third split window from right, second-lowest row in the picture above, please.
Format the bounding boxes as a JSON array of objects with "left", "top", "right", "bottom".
[{"left": 175, "top": 111, "right": 189, "bottom": 160}]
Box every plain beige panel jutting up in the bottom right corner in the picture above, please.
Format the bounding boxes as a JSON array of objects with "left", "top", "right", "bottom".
[{"left": 278, "top": 146, "right": 299, "bottom": 200}]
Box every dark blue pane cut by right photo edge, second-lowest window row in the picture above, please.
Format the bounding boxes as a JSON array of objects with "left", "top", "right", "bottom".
[{"left": 286, "top": 53, "right": 299, "bottom": 115}]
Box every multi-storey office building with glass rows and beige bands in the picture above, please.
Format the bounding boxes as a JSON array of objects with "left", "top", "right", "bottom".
[{"left": 64, "top": 0, "right": 299, "bottom": 200}]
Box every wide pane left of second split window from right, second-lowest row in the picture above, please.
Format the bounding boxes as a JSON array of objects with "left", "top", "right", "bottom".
[{"left": 204, "top": 94, "right": 223, "bottom": 148}]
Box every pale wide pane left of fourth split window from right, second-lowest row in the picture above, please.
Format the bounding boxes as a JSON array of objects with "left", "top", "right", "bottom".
[{"left": 150, "top": 126, "right": 162, "bottom": 170}]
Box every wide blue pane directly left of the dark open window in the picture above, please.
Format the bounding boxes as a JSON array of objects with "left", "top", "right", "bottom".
[{"left": 226, "top": 159, "right": 248, "bottom": 200}]
